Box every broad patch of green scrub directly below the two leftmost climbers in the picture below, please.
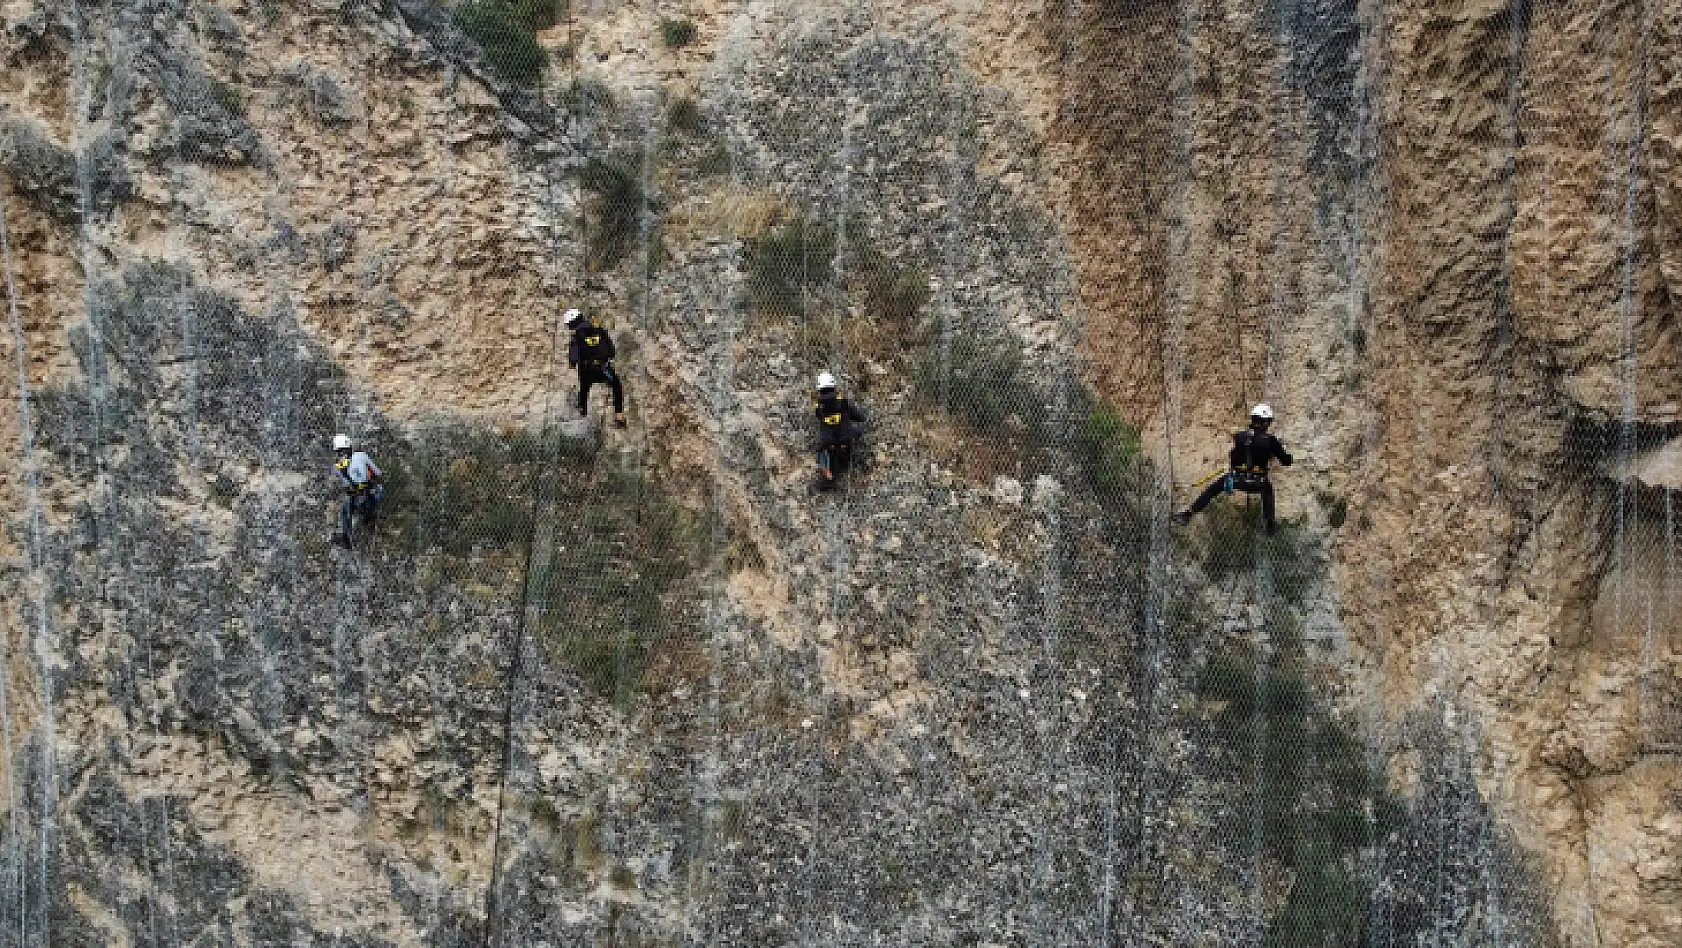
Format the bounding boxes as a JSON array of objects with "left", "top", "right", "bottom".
[{"left": 377, "top": 425, "right": 706, "bottom": 704}]
